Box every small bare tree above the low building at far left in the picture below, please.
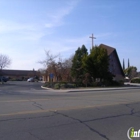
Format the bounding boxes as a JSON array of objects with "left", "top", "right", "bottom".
[{"left": 0, "top": 54, "right": 11, "bottom": 69}]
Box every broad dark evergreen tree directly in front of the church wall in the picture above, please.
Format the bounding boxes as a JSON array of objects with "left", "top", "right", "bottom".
[{"left": 82, "top": 46, "right": 109, "bottom": 80}]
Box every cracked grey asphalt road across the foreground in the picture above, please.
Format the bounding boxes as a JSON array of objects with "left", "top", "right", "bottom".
[{"left": 0, "top": 82, "right": 140, "bottom": 140}]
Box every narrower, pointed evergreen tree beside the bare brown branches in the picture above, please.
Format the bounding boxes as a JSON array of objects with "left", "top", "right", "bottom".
[{"left": 71, "top": 45, "right": 88, "bottom": 82}]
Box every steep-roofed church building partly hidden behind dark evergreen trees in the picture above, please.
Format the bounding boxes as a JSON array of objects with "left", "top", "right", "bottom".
[{"left": 99, "top": 44, "right": 125, "bottom": 80}]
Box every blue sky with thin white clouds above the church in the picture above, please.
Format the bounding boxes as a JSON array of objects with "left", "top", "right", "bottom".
[{"left": 0, "top": 0, "right": 140, "bottom": 71}]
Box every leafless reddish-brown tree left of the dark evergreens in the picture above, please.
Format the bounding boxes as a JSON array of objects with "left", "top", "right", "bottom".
[{"left": 39, "top": 51, "right": 73, "bottom": 81}]
